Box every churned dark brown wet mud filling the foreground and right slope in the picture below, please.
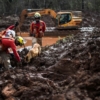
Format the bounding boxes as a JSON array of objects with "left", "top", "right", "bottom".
[{"left": 0, "top": 11, "right": 100, "bottom": 100}]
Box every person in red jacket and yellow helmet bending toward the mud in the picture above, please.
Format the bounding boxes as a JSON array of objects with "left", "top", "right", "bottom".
[{"left": 0, "top": 36, "right": 24, "bottom": 69}]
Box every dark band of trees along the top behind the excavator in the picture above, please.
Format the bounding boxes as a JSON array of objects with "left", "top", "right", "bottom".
[{"left": 0, "top": 0, "right": 100, "bottom": 15}]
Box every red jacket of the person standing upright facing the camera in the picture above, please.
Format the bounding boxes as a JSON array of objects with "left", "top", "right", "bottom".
[{"left": 30, "top": 20, "right": 46, "bottom": 37}]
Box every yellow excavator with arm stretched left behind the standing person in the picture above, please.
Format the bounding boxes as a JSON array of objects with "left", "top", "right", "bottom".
[{"left": 18, "top": 9, "right": 82, "bottom": 35}]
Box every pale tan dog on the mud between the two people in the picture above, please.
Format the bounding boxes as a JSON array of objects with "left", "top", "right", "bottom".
[{"left": 25, "top": 43, "right": 41, "bottom": 63}]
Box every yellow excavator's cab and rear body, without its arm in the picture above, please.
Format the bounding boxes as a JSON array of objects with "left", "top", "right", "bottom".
[{"left": 56, "top": 11, "right": 82, "bottom": 29}]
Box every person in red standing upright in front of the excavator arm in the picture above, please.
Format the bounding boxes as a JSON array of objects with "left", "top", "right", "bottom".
[{"left": 30, "top": 12, "right": 46, "bottom": 46}]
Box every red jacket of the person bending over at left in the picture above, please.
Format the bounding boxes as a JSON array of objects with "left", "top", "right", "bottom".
[{"left": 1, "top": 38, "right": 20, "bottom": 61}]
